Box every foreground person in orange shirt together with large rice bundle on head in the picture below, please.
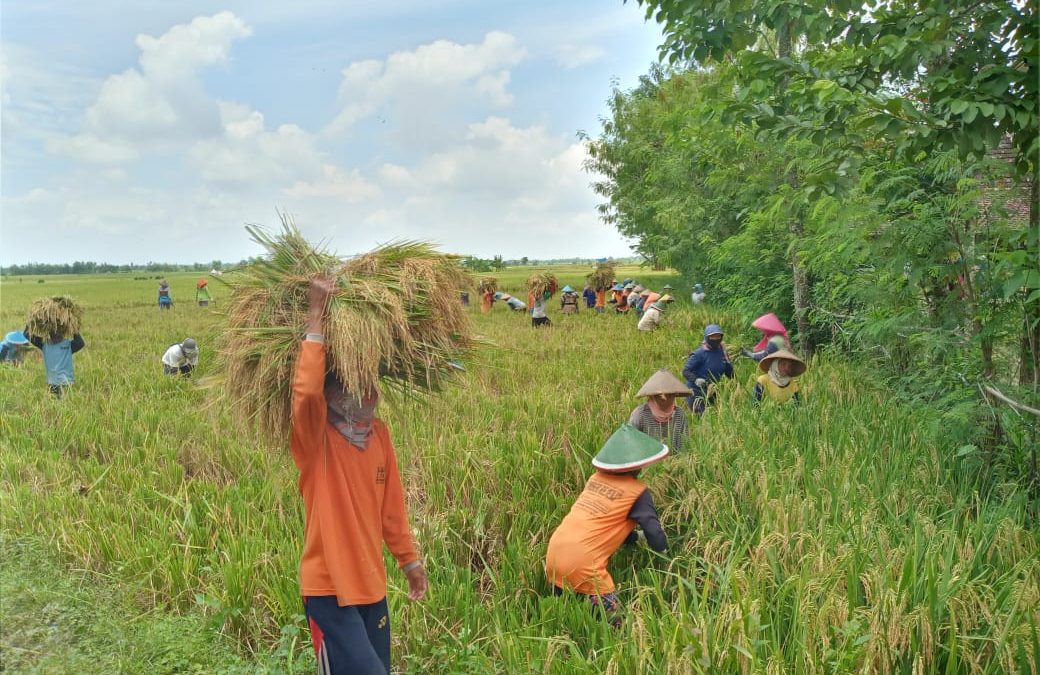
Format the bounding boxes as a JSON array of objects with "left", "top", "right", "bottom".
[{"left": 222, "top": 219, "right": 472, "bottom": 673}]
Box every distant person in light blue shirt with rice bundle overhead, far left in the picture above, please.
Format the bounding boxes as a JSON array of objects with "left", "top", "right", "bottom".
[{"left": 22, "top": 295, "right": 86, "bottom": 398}]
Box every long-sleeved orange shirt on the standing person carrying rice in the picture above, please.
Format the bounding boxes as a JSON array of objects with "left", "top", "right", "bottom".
[{"left": 289, "top": 340, "right": 419, "bottom": 606}]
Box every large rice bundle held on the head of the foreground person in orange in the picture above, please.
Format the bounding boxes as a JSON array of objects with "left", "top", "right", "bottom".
[{"left": 220, "top": 215, "right": 472, "bottom": 441}]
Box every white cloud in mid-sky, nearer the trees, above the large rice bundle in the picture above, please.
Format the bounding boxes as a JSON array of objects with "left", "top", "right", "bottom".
[{"left": 327, "top": 31, "right": 525, "bottom": 135}]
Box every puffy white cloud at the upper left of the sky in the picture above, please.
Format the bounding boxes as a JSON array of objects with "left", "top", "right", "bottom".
[{"left": 49, "top": 11, "right": 252, "bottom": 162}]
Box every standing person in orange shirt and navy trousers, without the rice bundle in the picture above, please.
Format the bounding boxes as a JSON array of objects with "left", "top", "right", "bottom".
[{"left": 289, "top": 278, "right": 426, "bottom": 675}]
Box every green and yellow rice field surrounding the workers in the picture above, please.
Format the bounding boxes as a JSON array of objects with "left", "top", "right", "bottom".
[{"left": 0, "top": 267, "right": 1040, "bottom": 674}]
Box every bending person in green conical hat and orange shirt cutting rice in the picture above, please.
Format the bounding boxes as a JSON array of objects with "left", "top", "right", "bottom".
[{"left": 545, "top": 424, "right": 669, "bottom": 626}]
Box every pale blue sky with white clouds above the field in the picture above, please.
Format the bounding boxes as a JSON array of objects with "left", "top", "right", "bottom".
[{"left": 0, "top": 0, "right": 660, "bottom": 264}]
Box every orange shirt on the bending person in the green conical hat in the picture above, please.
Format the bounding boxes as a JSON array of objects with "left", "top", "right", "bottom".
[{"left": 545, "top": 471, "right": 647, "bottom": 595}]
